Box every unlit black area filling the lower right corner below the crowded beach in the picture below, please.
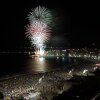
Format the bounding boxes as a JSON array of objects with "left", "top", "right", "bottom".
[{"left": 53, "top": 70, "right": 100, "bottom": 100}]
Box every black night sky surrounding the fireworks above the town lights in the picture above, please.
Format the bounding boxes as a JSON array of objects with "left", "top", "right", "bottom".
[{"left": 0, "top": 0, "right": 100, "bottom": 49}]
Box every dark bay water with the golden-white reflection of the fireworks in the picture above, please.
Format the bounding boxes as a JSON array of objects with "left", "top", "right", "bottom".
[{"left": 0, "top": 54, "right": 76, "bottom": 76}]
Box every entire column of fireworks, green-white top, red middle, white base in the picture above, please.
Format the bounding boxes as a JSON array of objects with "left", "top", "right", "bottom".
[{"left": 26, "top": 6, "right": 52, "bottom": 48}]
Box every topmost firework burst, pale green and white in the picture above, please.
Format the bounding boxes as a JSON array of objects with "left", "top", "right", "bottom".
[{"left": 28, "top": 6, "right": 52, "bottom": 24}]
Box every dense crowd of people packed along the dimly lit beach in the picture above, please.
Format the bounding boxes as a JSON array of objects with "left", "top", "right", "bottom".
[{"left": 0, "top": 58, "right": 98, "bottom": 98}]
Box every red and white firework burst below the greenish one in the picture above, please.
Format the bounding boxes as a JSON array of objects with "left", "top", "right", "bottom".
[{"left": 26, "top": 21, "right": 50, "bottom": 44}]
